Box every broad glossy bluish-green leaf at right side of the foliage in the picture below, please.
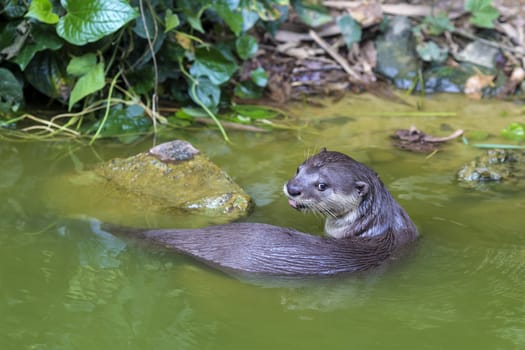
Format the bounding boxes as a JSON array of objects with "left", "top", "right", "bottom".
[{"left": 190, "top": 47, "right": 237, "bottom": 85}]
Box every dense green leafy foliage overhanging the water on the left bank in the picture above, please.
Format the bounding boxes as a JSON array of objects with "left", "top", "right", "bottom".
[{"left": 0, "top": 0, "right": 286, "bottom": 142}]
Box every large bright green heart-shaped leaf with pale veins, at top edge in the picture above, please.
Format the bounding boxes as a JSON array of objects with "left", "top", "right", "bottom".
[{"left": 57, "top": 0, "right": 137, "bottom": 46}]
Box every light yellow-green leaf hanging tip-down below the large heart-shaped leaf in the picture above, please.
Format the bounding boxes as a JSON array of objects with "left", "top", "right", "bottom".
[{"left": 67, "top": 53, "right": 106, "bottom": 110}]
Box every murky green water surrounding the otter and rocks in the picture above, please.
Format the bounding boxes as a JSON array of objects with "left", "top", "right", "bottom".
[{"left": 0, "top": 96, "right": 525, "bottom": 349}]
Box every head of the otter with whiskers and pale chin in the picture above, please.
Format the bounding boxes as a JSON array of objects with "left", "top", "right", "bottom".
[{"left": 283, "top": 149, "right": 371, "bottom": 218}]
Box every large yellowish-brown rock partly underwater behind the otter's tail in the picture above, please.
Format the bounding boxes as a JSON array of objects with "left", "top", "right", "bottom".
[{"left": 44, "top": 140, "right": 252, "bottom": 226}]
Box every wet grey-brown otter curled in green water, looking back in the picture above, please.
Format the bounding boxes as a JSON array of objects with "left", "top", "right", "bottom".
[{"left": 107, "top": 149, "right": 418, "bottom": 276}]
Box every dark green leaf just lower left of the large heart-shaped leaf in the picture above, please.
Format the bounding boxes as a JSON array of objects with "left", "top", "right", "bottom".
[{"left": 12, "top": 23, "right": 63, "bottom": 71}]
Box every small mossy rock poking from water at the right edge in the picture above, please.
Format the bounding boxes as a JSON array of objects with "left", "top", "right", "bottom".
[{"left": 458, "top": 149, "right": 525, "bottom": 187}]
